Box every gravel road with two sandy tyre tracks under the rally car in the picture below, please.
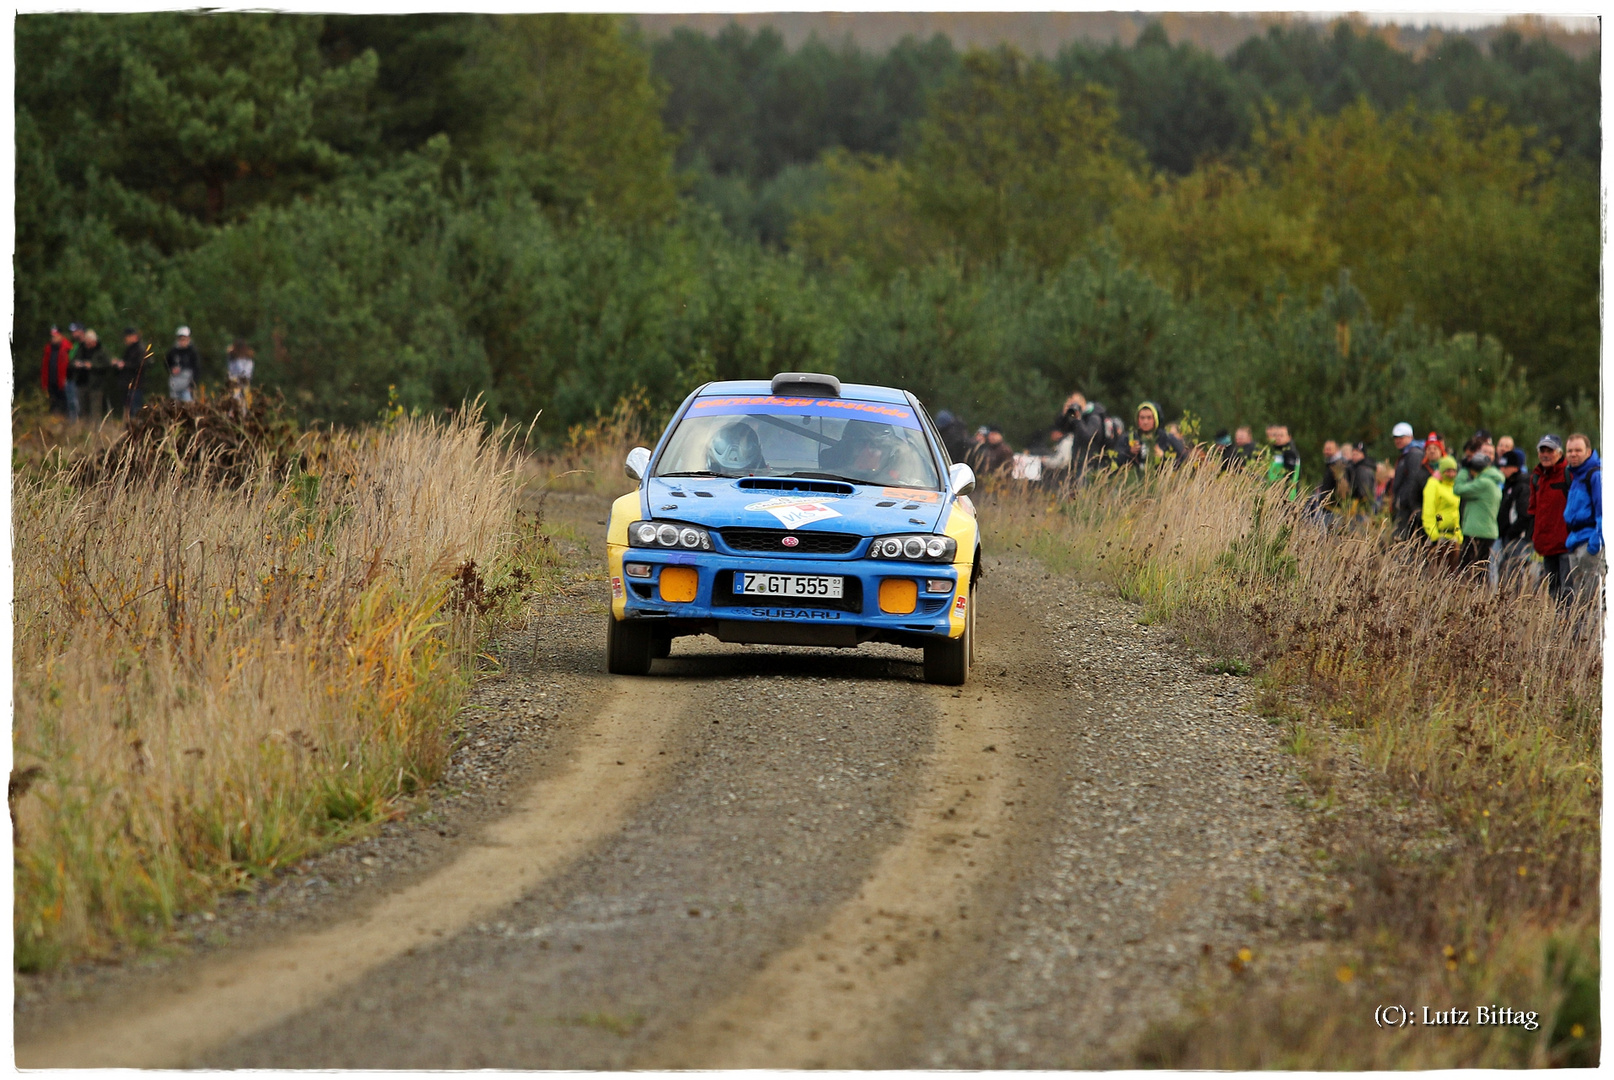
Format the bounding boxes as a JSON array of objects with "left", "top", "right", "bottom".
[{"left": 18, "top": 499, "right": 1309, "bottom": 1069}]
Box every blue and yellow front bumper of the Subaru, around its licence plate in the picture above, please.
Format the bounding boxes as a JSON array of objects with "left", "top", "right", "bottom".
[{"left": 608, "top": 544, "right": 970, "bottom": 647}]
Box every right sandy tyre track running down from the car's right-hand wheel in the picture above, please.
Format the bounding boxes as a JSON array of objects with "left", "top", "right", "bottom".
[{"left": 634, "top": 577, "right": 1071, "bottom": 1069}]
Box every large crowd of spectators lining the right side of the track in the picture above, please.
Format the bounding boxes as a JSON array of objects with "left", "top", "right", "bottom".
[{"left": 936, "top": 392, "right": 1604, "bottom": 602}]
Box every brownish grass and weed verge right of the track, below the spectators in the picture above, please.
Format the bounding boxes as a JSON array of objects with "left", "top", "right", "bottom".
[{"left": 980, "top": 470, "right": 1601, "bottom": 1069}]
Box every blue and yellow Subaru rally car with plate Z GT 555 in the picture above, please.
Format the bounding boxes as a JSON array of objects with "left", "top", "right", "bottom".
[{"left": 605, "top": 373, "right": 981, "bottom": 686}]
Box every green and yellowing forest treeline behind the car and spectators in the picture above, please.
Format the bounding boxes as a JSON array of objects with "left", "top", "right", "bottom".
[{"left": 13, "top": 13, "right": 1599, "bottom": 458}]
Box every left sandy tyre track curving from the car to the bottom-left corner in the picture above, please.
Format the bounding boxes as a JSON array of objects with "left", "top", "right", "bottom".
[{"left": 16, "top": 680, "right": 689, "bottom": 1069}]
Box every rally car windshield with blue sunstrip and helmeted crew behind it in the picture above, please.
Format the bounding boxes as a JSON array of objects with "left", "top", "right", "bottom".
[{"left": 655, "top": 397, "right": 941, "bottom": 491}]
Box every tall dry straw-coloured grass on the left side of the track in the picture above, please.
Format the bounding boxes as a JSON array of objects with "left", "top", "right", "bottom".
[{"left": 10, "top": 415, "right": 515, "bottom": 969}]
